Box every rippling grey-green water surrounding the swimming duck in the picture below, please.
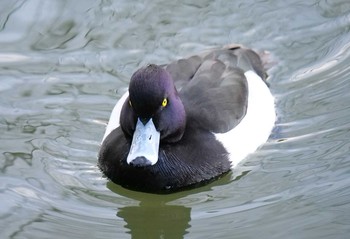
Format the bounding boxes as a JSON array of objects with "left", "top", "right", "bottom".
[{"left": 0, "top": 0, "right": 350, "bottom": 238}]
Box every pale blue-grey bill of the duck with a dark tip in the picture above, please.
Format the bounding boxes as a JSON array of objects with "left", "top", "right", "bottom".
[{"left": 126, "top": 119, "right": 160, "bottom": 167}]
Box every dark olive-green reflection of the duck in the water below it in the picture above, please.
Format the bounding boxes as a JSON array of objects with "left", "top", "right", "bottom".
[{"left": 107, "top": 172, "right": 248, "bottom": 239}]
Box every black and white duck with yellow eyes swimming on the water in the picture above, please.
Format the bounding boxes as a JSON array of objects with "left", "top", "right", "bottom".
[{"left": 98, "top": 45, "right": 276, "bottom": 194}]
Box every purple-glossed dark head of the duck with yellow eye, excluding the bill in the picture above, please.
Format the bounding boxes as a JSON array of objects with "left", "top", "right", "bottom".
[{"left": 120, "top": 64, "right": 186, "bottom": 142}]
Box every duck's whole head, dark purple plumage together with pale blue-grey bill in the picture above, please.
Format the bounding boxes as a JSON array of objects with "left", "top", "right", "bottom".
[{"left": 120, "top": 64, "right": 186, "bottom": 167}]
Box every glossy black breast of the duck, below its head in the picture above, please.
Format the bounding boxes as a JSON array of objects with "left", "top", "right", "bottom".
[{"left": 99, "top": 126, "right": 230, "bottom": 193}]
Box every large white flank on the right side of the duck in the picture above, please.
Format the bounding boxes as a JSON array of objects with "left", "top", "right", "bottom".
[{"left": 215, "top": 71, "right": 276, "bottom": 167}]
